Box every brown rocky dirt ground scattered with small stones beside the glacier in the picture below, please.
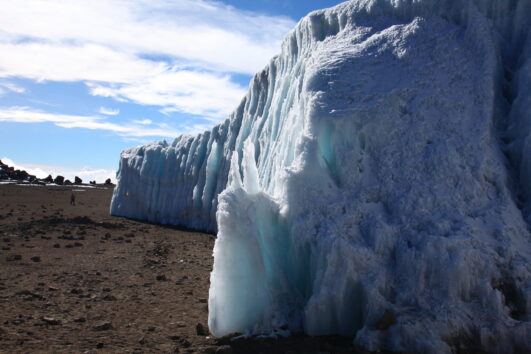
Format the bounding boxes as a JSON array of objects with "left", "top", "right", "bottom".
[{"left": 0, "top": 184, "right": 366, "bottom": 354}]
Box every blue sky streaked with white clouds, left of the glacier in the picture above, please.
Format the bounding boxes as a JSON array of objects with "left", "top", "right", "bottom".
[{"left": 0, "top": 0, "right": 342, "bottom": 182}]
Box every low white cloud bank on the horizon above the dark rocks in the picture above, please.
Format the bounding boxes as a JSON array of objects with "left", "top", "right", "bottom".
[{"left": 2, "top": 157, "right": 116, "bottom": 183}]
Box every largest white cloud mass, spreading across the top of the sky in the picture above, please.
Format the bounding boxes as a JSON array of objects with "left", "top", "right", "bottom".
[{"left": 0, "top": 0, "right": 294, "bottom": 120}]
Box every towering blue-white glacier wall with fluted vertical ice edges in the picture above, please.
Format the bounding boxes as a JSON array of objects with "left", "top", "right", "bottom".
[{"left": 111, "top": 0, "right": 531, "bottom": 353}]
